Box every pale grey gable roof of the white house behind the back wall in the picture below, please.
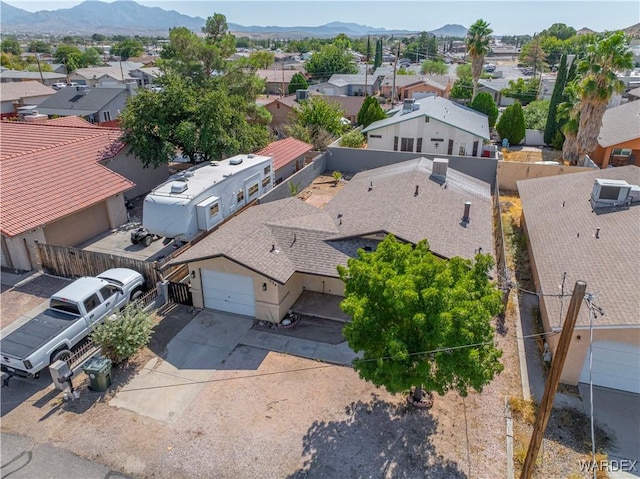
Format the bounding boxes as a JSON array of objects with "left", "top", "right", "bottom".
[{"left": 362, "top": 96, "right": 489, "bottom": 140}]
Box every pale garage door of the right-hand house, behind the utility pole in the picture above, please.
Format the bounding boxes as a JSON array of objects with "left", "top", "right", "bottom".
[{"left": 580, "top": 341, "right": 640, "bottom": 393}]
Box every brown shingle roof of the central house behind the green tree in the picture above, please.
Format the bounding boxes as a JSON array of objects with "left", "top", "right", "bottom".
[{"left": 172, "top": 158, "right": 493, "bottom": 283}]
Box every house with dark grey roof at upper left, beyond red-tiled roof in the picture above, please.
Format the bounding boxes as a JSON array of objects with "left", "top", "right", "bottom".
[{"left": 38, "top": 86, "right": 133, "bottom": 123}]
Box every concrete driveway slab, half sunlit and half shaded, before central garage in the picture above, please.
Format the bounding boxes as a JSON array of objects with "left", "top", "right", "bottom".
[{"left": 109, "top": 311, "right": 253, "bottom": 422}]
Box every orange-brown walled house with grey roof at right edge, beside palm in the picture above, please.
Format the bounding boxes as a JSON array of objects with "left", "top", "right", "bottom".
[{"left": 590, "top": 101, "right": 640, "bottom": 168}]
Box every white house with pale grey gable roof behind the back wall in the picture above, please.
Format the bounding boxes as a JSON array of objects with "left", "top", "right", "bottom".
[{"left": 362, "top": 96, "right": 489, "bottom": 157}]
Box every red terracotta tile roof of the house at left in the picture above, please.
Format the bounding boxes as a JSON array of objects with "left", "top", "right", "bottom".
[{"left": 0, "top": 122, "right": 135, "bottom": 236}]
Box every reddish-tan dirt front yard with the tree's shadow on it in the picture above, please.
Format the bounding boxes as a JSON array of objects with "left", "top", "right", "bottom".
[{"left": 1, "top": 276, "right": 520, "bottom": 479}]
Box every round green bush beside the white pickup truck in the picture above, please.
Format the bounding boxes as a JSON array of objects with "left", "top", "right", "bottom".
[{"left": 91, "top": 303, "right": 154, "bottom": 364}]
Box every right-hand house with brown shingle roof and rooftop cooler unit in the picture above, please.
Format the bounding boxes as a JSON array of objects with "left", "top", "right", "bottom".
[{"left": 517, "top": 166, "right": 640, "bottom": 393}]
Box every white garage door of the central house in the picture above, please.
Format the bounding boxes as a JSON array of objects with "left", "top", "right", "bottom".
[{"left": 202, "top": 269, "right": 256, "bottom": 317}]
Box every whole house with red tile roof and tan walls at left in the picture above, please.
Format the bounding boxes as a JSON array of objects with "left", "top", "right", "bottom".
[{"left": 0, "top": 118, "right": 168, "bottom": 270}]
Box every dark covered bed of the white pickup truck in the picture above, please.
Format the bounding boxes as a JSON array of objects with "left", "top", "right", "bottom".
[{"left": 0, "top": 309, "right": 82, "bottom": 359}]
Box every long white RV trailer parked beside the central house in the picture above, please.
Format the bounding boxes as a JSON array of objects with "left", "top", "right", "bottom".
[{"left": 142, "top": 154, "right": 274, "bottom": 242}]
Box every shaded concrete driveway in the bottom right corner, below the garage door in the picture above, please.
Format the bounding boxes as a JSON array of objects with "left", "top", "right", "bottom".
[{"left": 578, "top": 383, "right": 640, "bottom": 479}]
